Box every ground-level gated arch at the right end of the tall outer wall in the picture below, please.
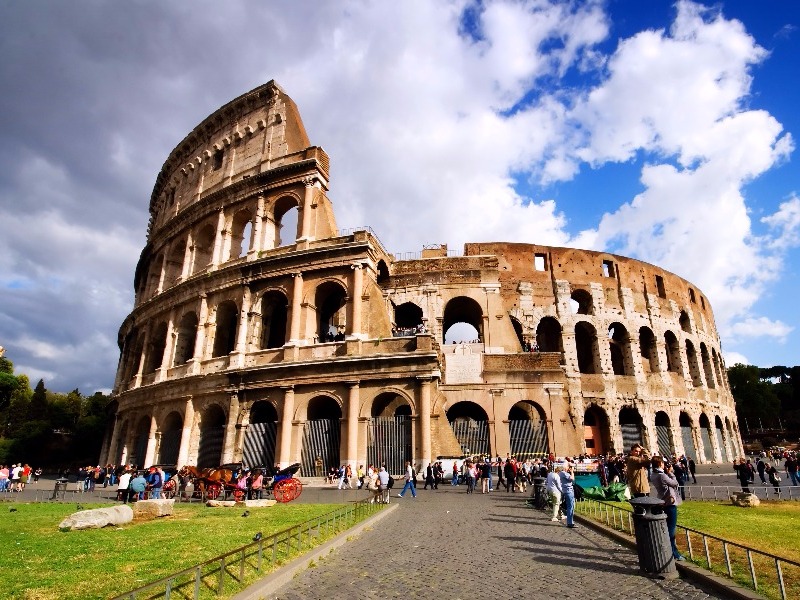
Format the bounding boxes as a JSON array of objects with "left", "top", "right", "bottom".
[{"left": 367, "top": 392, "right": 414, "bottom": 473}]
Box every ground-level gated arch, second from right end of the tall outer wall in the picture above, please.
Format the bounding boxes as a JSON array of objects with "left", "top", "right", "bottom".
[{"left": 298, "top": 396, "right": 342, "bottom": 475}]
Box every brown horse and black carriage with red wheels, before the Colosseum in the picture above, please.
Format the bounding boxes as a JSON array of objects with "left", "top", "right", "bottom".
[{"left": 178, "top": 463, "right": 303, "bottom": 502}]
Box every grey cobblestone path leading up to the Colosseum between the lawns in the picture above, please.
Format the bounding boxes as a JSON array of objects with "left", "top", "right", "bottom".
[{"left": 269, "top": 486, "right": 723, "bottom": 600}]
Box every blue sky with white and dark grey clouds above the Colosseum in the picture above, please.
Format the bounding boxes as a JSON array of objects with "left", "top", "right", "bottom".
[{"left": 0, "top": 0, "right": 800, "bottom": 393}]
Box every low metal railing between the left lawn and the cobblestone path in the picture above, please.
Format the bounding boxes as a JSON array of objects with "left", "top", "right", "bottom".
[{"left": 113, "top": 500, "right": 386, "bottom": 600}]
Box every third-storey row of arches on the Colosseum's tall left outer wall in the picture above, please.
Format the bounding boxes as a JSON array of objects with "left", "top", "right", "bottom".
[{"left": 137, "top": 195, "right": 302, "bottom": 301}]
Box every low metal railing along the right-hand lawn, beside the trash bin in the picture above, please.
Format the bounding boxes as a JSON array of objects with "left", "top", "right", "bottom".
[{"left": 575, "top": 500, "right": 800, "bottom": 600}]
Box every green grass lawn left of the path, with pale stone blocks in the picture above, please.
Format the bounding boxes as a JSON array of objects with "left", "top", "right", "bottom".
[{"left": 0, "top": 503, "right": 354, "bottom": 600}]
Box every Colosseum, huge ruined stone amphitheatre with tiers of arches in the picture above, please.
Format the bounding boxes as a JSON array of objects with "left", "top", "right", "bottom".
[{"left": 100, "top": 82, "right": 741, "bottom": 475}]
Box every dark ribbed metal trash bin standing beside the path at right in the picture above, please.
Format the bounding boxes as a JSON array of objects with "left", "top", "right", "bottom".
[{"left": 629, "top": 496, "right": 678, "bottom": 578}]
